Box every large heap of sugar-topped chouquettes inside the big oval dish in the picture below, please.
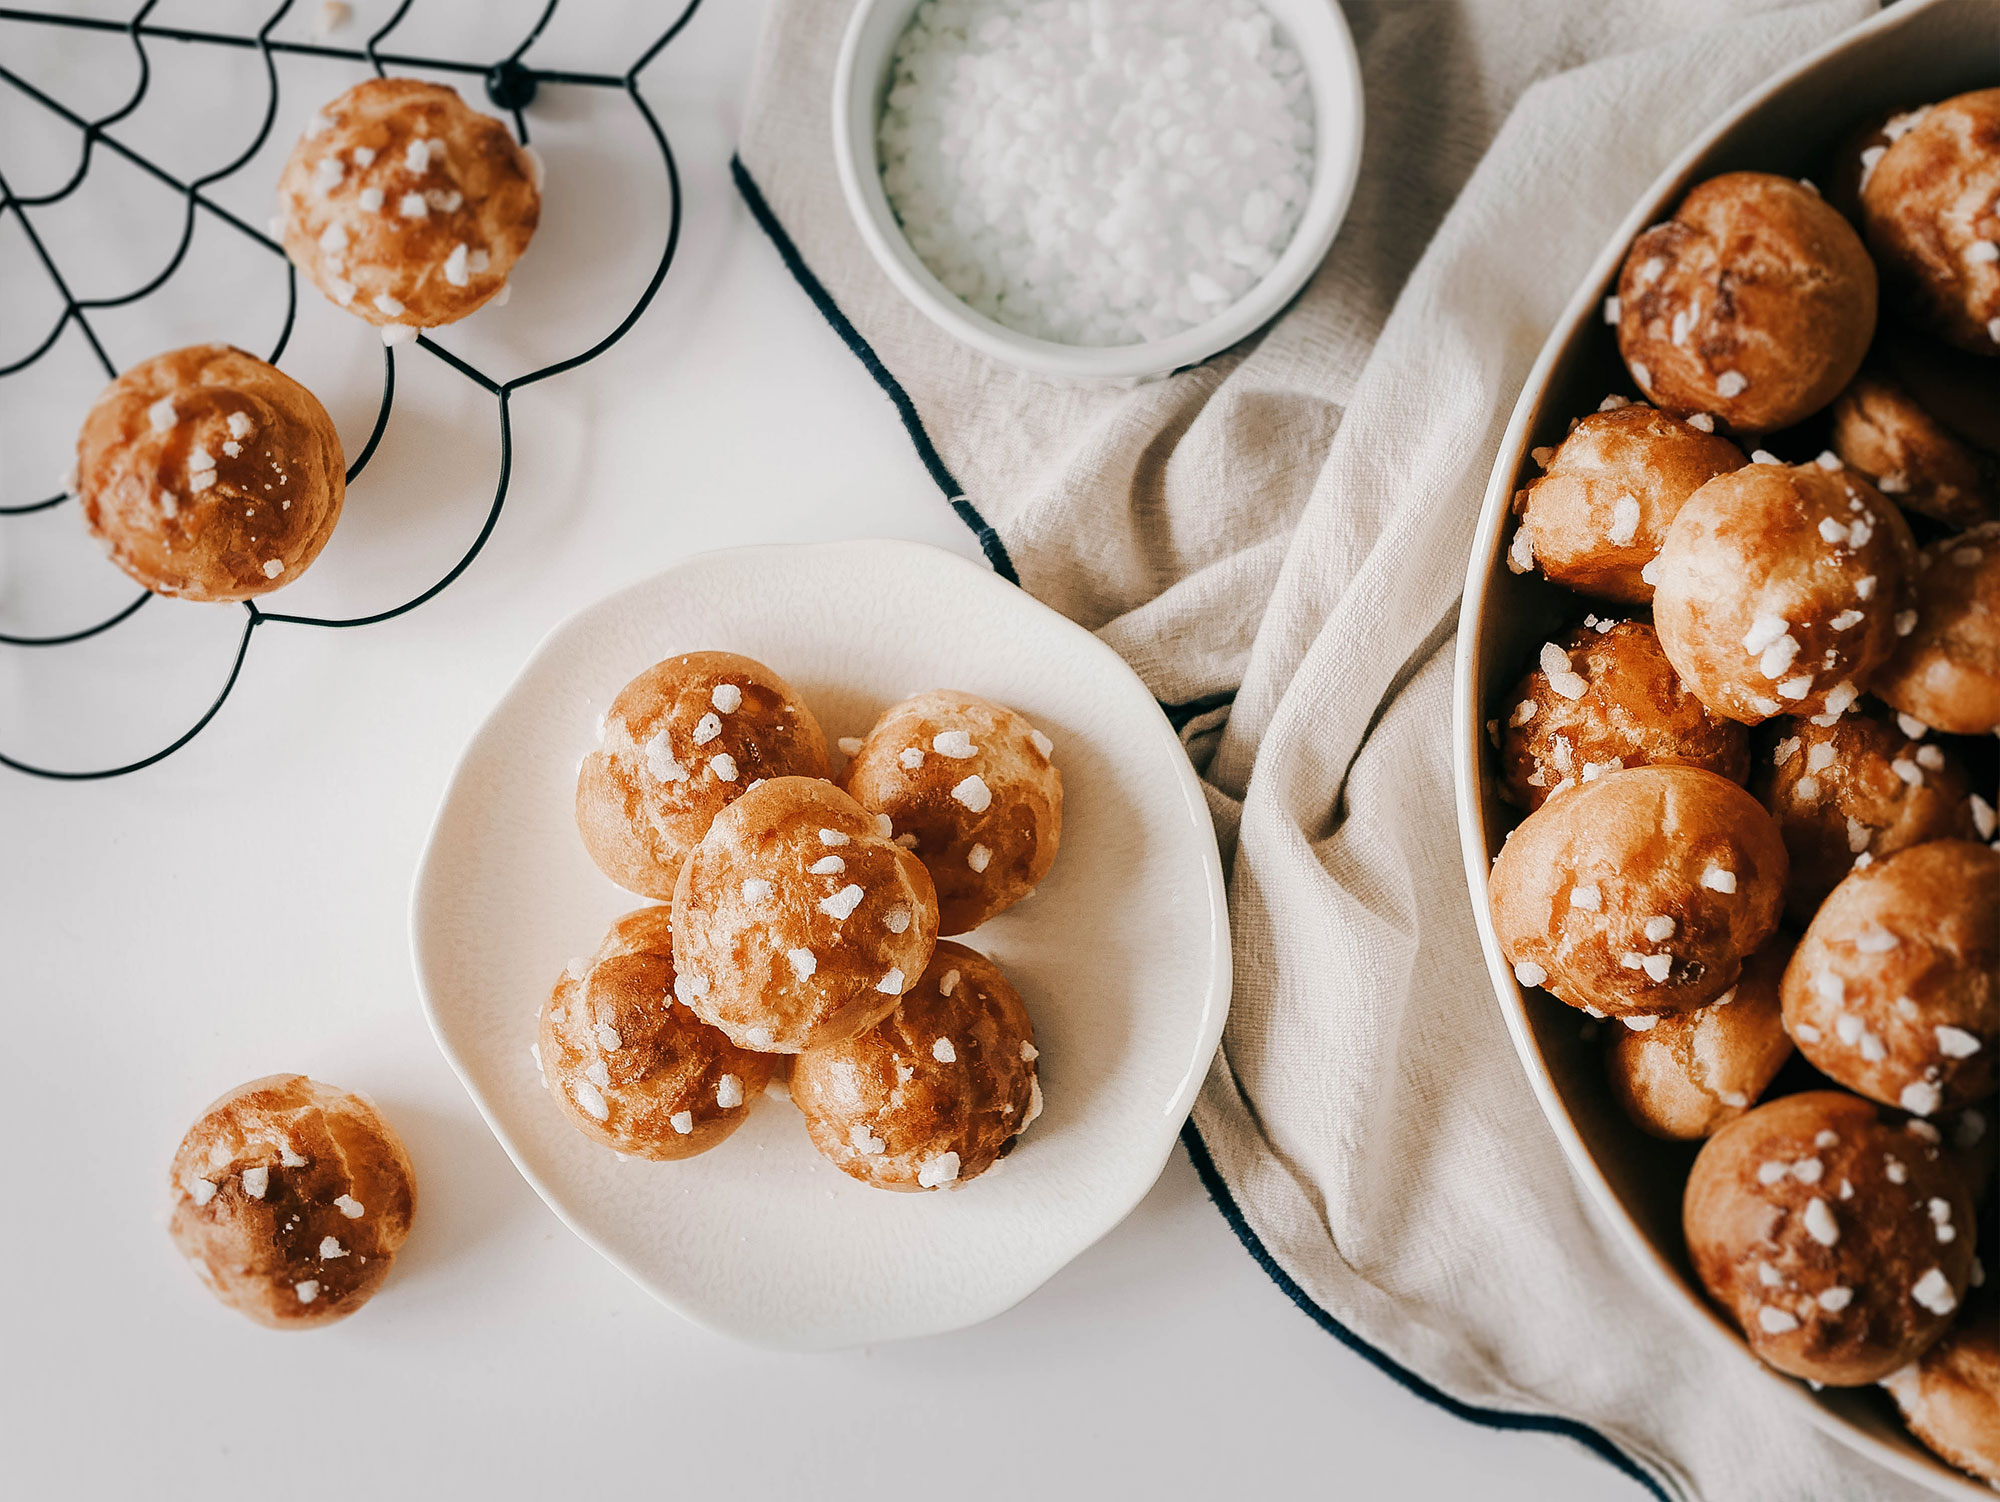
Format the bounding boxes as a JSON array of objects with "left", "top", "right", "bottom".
[{"left": 1488, "top": 90, "right": 2000, "bottom": 1484}]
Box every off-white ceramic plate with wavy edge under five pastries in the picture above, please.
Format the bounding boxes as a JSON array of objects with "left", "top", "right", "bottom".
[{"left": 410, "top": 542, "right": 1230, "bottom": 1350}]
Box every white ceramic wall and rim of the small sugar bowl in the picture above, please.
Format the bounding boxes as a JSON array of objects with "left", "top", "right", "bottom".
[{"left": 834, "top": 0, "right": 1362, "bottom": 380}]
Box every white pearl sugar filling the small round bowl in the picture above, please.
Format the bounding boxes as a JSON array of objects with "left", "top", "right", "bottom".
[{"left": 878, "top": 0, "right": 1314, "bottom": 346}]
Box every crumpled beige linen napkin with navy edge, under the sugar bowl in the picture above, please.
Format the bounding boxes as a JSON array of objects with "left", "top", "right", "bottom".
[{"left": 738, "top": 0, "right": 1952, "bottom": 1500}]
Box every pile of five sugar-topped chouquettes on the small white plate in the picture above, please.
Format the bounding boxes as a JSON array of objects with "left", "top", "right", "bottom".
[{"left": 532, "top": 652, "right": 1062, "bottom": 1190}]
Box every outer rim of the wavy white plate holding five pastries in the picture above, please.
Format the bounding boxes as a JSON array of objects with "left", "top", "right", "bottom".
[{"left": 408, "top": 538, "right": 1234, "bottom": 1352}]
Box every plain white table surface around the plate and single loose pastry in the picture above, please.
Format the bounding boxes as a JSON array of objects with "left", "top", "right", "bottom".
[{"left": 0, "top": 0, "right": 1638, "bottom": 1500}]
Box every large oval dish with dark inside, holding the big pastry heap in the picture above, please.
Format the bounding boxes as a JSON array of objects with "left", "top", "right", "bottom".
[{"left": 1454, "top": 4, "right": 2000, "bottom": 1502}]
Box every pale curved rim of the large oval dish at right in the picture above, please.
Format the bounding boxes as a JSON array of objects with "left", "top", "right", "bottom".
[{"left": 1452, "top": 4, "right": 1992, "bottom": 1500}]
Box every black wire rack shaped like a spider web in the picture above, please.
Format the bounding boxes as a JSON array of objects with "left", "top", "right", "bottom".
[{"left": 0, "top": 0, "right": 700, "bottom": 782}]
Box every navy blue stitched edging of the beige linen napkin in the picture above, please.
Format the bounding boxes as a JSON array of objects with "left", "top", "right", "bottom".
[{"left": 730, "top": 156, "right": 1674, "bottom": 1502}]
